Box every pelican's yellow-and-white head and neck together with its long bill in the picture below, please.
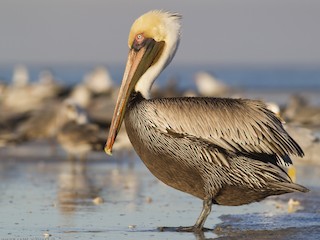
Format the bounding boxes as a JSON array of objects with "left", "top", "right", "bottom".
[{"left": 105, "top": 10, "right": 181, "bottom": 155}]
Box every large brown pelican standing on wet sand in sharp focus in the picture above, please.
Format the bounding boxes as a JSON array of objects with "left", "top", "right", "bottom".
[{"left": 105, "top": 11, "right": 308, "bottom": 232}]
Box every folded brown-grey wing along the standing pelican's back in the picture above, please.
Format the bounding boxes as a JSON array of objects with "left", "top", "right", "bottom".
[{"left": 146, "top": 98, "right": 303, "bottom": 165}]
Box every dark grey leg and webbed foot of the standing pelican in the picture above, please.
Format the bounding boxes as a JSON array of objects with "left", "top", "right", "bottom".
[{"left": 177, "top": 198, "right": 212, "bottom": 232}]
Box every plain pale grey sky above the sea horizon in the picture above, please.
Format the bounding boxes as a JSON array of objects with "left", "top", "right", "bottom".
[{"left": 0, "top": 0, "right": 320, "bottom": 66}]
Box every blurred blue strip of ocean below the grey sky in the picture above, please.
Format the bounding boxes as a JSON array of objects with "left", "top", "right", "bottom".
[{"left": 0, "top": 64, "right": 320, "bottom": 91}]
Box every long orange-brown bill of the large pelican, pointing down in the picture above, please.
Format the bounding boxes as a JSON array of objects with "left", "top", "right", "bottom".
[{"left": 104, "top": 39, "right": 164, "bottom": 155}]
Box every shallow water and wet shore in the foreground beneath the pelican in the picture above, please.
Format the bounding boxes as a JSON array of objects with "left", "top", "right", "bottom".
[{"left": 0, "top": 142, "right": 320, "bottom": 240}]
